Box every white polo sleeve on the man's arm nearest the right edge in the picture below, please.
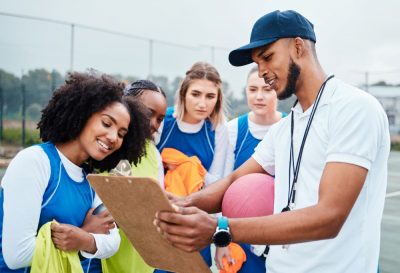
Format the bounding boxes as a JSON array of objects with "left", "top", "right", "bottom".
[{"left": 326, "top": 91, "right": 386, "bottom": 170}]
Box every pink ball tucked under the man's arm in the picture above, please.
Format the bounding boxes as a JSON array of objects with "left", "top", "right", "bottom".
[{"left": 222, "top": 173, "right": 274, "bottom": 218}]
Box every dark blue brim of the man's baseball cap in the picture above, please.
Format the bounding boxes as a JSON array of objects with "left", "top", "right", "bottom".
[{"left": 229, "top": 38, "right": 279, "bottom": 66}]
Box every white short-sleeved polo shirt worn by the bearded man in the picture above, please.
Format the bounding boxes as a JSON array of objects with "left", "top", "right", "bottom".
[{"left": 253, "top": 78, "right": 390, "bottom": 273}]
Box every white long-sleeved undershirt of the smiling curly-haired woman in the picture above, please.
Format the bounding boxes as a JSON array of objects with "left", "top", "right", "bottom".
[{"left": 1, "top": 146, "right": 120, "bottom": 269}]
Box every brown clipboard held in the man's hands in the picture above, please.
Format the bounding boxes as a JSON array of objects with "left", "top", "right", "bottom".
[{"left": 87, "top": 174, "right": 211, "bottom": 273}]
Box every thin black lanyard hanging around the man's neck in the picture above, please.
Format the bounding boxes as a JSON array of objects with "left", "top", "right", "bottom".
[{"left": 282, "top": 75, "right": 334, "bottom": 212}]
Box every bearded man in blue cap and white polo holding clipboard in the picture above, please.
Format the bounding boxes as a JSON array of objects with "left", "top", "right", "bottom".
[{"left": 155, "top": 11, "right": 390, "bottom": 273}]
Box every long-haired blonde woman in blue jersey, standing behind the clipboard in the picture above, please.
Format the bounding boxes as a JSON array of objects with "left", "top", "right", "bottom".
[{"left": 157, "top": 62, "right": 228, "bottom": 266}]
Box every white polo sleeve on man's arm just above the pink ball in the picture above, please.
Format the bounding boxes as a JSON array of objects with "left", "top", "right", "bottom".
[{"left": 252, "top": 126, "right": 276, "bottom": 175}]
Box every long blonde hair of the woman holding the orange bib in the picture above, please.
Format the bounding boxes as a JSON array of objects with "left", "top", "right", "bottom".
[{"left": 174, "top": 62, "right": 225, "bottom": 129}]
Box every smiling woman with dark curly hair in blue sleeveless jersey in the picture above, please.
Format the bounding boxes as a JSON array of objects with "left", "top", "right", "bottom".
[{"left": 0, "top": 73, "right": 150, "bottom": 272}]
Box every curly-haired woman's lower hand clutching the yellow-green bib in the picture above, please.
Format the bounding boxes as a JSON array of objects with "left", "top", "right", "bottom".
[{"left": 51, "top": 223, "right": 97, "bottom": 254}]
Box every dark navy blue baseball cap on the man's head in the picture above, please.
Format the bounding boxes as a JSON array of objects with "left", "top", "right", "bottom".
[{"left": 229, "top": 10, "right": 317, "bottom": 66}]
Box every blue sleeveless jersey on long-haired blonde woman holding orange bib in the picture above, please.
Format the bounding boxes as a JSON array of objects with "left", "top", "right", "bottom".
[{"left": 157, "top": 107, "right": 215, "bottom": 170}]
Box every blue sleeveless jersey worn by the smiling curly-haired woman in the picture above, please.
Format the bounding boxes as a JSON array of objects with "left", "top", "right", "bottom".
[{"left": 0, "top": 142, "right": 97, "bottom": 273}]
